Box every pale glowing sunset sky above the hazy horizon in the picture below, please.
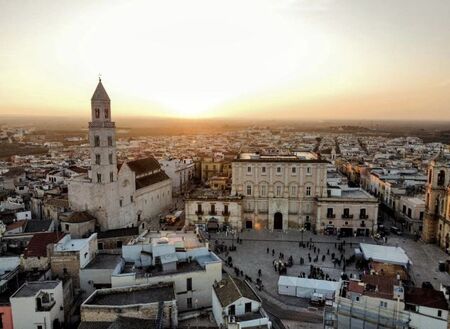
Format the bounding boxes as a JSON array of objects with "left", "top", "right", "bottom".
[{"left": 0, "top": 0, "right": 450, "bottom": 120}]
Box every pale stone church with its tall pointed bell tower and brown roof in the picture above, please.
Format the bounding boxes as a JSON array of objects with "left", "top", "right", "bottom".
[{"left": 69, "top": 80, "right": 172, "bottom": 231}]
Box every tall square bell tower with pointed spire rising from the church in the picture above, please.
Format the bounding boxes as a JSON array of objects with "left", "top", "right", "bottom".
[{"left": 89, "top": 78, "right": 117, "bottom": 184}]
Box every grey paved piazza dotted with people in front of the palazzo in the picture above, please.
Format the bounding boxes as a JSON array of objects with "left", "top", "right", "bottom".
[{"left": 210, "top": 230, "right": 450, "bottom": 300}]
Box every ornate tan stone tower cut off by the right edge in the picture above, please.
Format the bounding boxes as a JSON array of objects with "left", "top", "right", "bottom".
[{"left": 422, "top": 150, "right": 450, "bottom": 243}]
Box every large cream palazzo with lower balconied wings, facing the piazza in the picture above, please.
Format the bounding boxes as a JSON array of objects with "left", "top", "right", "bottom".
[{"left": 186, "top": 152, "right": 378, "bottom": 235}]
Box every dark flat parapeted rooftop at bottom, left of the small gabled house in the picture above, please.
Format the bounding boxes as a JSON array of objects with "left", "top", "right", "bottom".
[{"left": 83, "top": 283, "right": 175, "bottom": 306}]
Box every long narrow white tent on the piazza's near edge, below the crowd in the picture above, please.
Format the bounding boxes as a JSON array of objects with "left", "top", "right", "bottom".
[{"left": 278, "top": 275, "right": 341, "bottom": 298}]
